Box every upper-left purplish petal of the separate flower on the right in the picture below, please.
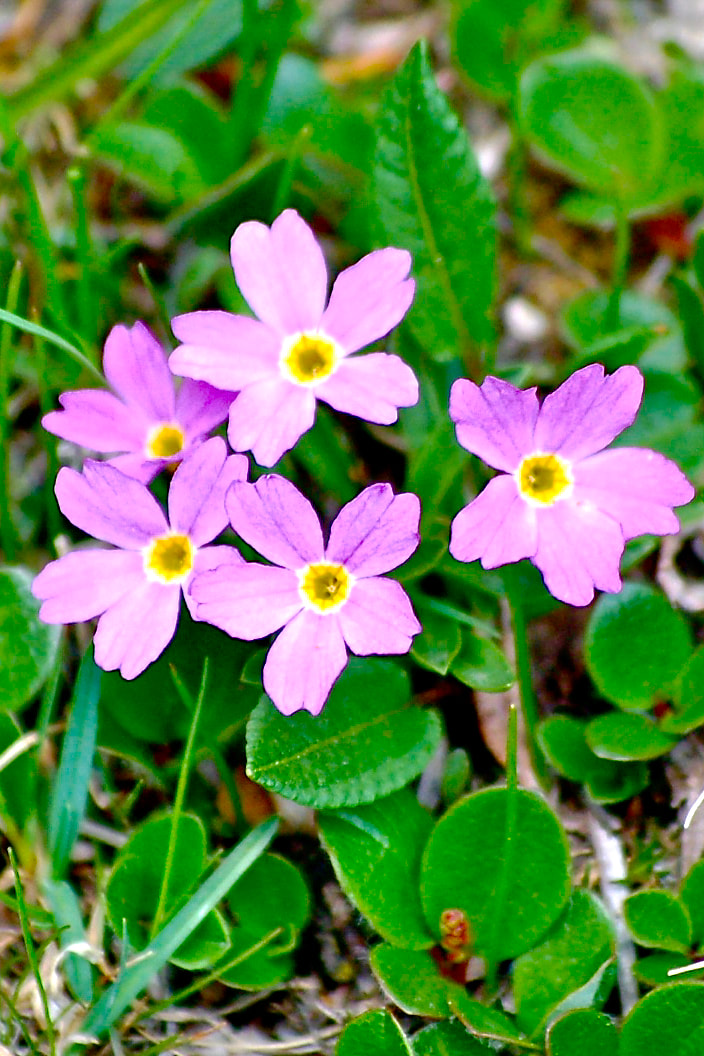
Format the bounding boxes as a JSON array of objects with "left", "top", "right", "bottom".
[{"left": 450, "top": 377, "right": 538, "bottom": 473}]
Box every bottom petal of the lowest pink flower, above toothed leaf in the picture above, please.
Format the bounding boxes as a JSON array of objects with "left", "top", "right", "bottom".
[{"left": 264, "top": 610, "right": 347, "bottom": 715}]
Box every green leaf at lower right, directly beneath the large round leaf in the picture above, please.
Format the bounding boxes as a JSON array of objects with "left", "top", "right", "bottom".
[{"left": 513, "top": 890, "right": 614, "bottom": 1036}]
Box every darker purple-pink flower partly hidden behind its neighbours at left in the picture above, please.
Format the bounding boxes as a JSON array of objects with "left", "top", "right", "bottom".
[{"left": 42, "top": 322, "right": 234, "bottom": 484}]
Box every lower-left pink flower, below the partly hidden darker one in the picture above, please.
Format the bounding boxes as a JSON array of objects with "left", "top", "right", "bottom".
[{"left": 32, "top": 436, "right": 248, "bottom": 679}]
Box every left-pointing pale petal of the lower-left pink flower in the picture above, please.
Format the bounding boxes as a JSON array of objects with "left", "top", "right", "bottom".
[{"left": 32, "top": 550, "right": 145, "bottom": 623}]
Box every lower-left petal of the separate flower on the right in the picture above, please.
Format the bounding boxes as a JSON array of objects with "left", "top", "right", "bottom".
[{"left": 450, "top": 474, "right": 537, "bottom": 568}]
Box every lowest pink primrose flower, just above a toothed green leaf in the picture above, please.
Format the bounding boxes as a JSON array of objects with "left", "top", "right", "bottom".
[{"left": 191, "top": 474, "right": 422, "bottom": 715}]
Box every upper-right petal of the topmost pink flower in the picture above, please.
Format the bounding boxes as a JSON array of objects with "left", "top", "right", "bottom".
[{"left": 320, "top": 248, "right": 416, "bottom": 353}]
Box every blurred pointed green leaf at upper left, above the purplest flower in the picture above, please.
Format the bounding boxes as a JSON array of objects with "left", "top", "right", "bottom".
[{"left": 91, "top": 121, "right": 205, "bottom": 206}]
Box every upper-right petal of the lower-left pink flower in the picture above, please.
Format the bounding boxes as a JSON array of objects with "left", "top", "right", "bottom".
[{"left": 169, "top": 436, "right": 249, "bottom": 546}]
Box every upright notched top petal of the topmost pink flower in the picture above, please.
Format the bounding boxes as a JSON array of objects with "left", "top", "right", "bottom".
[{"left": 230, "top": 209, "right": 327, "bottom": 335}]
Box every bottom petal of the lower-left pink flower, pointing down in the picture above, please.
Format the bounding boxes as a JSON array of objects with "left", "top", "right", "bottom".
[{"left": 94, "top": 582, "right": 180, "bottom": 679}]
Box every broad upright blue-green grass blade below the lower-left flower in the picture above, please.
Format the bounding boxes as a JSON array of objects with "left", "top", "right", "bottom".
[{"left": 49, "top": 648, "right": 101, "bottom": 880}]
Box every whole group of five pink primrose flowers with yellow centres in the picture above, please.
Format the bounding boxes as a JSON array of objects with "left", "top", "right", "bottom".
[{"left": 33, "top": 209, "right": 693, "bottom": 715}]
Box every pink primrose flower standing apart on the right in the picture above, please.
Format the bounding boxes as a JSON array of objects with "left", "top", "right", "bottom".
[{"left": 450, "top": 363, "right": 695, "bottom": 605}]
